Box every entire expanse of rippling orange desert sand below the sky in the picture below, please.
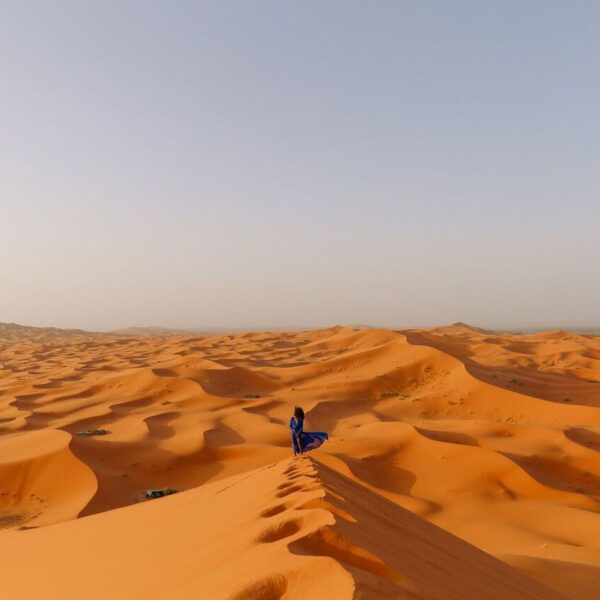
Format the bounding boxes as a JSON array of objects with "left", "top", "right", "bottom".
[{"left": 0, "top": 324, "right": 600, "bottom": 600}]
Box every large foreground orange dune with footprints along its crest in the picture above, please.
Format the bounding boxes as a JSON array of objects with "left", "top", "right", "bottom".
[{"left": 0, "top": 458, "right": 560, "bottom": 600}]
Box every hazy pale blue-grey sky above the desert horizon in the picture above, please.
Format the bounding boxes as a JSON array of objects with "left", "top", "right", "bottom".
[{"left": 0, "top": 0, "right": 600, "bottom": 329}]
